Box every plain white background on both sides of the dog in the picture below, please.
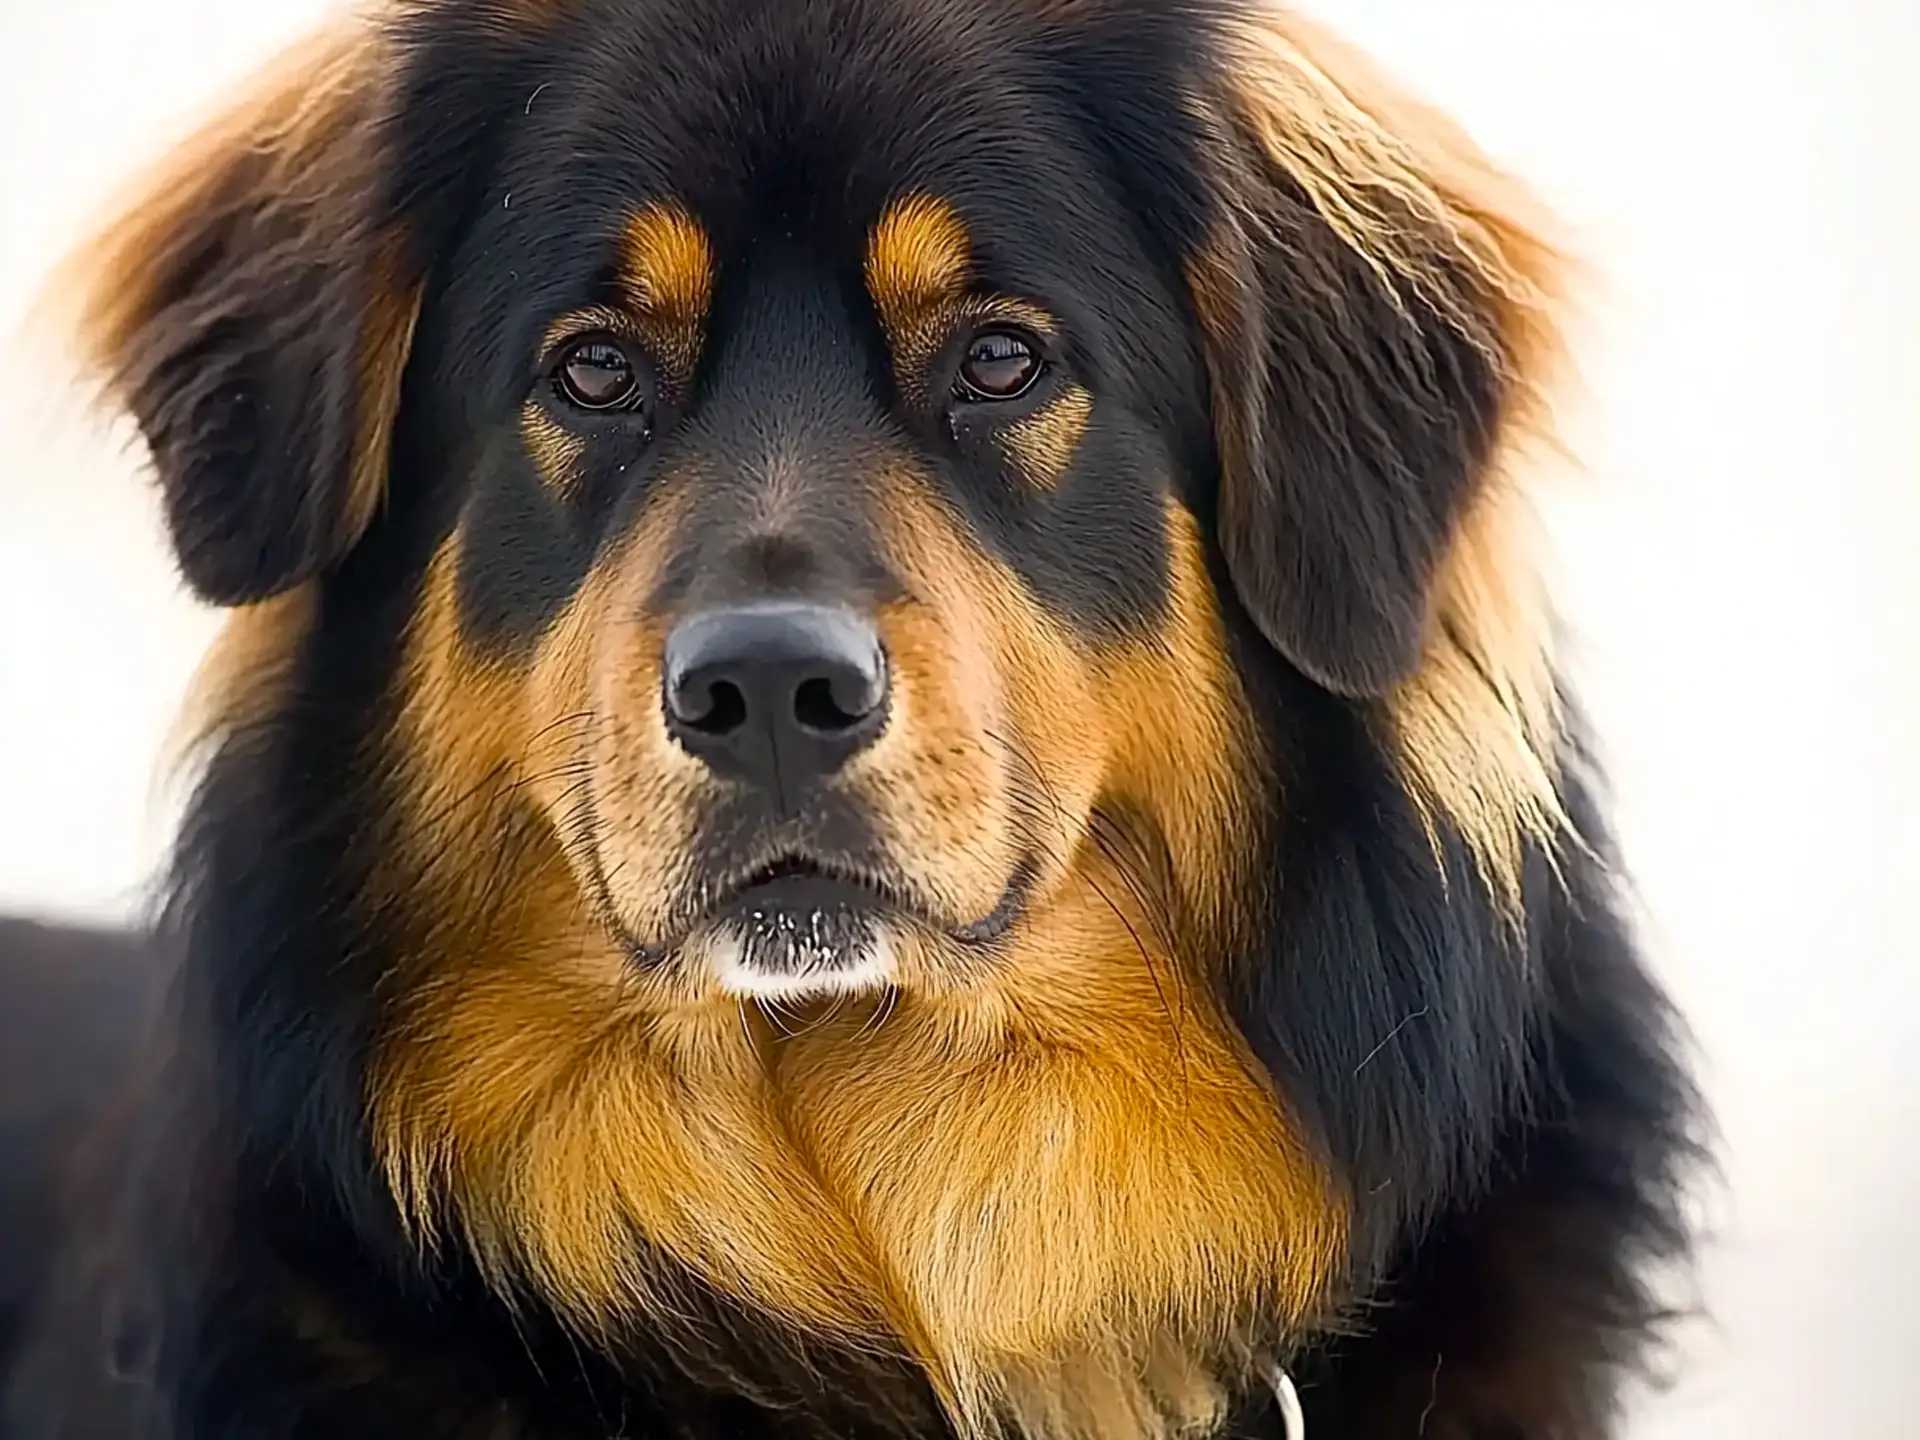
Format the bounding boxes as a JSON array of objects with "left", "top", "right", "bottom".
[{"left": 0, "top": 0, "right": 1920, "bottom": 1440}]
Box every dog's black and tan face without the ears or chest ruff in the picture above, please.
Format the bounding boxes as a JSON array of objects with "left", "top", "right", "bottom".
[{"left": 370, "top": 6, "right": 1261, "bottom": 1023}]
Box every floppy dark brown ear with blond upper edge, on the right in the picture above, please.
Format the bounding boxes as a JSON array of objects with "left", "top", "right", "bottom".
[{"left": 1188, "top": 12, "right": 1561, "bottom": 697}]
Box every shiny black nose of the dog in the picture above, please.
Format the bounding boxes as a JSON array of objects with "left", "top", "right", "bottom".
[{"left": 664, "top": 603, "right": 887, "bottom": 803}]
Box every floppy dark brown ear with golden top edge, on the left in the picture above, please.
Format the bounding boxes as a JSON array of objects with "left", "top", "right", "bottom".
[{"left": 63, "top": 25, "right": 419, "bottom": 605}]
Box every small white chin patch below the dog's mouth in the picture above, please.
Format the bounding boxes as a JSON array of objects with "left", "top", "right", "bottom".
[{"left": 705, "top": 910, "right": 893, "bottom": 1000}]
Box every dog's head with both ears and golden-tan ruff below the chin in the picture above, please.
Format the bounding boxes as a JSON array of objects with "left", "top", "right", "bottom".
[{"left": 60, "top": 0, "right": 1557, "bottom": 1432}]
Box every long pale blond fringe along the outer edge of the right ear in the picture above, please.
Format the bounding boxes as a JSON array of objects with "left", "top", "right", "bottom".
[{"left": 1229, "top": 6, "right": 1586, "bottom": 916}]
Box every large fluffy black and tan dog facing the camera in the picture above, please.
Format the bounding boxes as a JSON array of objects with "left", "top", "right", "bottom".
[{"left": 15, "top": 0, "right": 1703, "bottom": 1440}]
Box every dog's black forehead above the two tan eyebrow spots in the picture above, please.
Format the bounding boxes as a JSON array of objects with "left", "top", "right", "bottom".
[{"left": 435, "top": 0, "right": 1198, "bottom": 299}]
